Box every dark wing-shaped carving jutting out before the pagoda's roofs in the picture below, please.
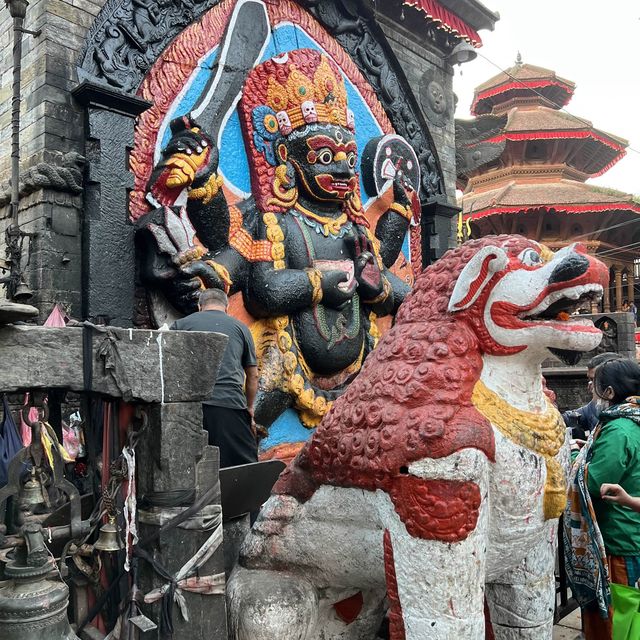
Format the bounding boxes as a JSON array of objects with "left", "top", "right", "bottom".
[{"left": 456, "top": 115, "right": 507, "bottom": 178}]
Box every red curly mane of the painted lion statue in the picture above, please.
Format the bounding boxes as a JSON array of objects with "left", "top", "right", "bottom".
[{"left": 274, "top": 236, "right": 548, "bottom": 512}]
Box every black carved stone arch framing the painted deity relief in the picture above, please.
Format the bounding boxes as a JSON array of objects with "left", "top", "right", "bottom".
[{"left": 78, "top": 0, "right": 444, "bottom": 202}]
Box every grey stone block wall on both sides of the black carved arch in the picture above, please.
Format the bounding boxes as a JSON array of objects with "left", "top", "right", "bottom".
[{"left": 0, "top": 0, "right": 482, "bottom": 320}]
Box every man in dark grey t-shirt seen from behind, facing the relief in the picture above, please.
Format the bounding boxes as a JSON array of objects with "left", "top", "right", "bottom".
[{"left": 171, "top": 289, "right": 258, "bottom": 467}]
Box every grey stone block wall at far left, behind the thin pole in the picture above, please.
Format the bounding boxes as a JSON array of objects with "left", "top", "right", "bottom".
[{"left": 0, "top": 0, "right": 104, "bottom": 316}]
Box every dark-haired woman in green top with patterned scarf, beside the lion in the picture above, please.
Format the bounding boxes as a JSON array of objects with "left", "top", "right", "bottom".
[{"left": 564, "top": 359, "right": 640, "bottom": 640}]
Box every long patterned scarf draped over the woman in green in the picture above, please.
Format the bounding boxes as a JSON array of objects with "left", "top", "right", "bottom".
[{"left": 563, "top": 396, "right": 640, "bottom": 618}]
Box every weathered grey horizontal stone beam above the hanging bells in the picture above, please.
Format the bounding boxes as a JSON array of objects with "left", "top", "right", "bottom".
[{"left": 0, "top": 325, "right": 227, "bottom": 403}]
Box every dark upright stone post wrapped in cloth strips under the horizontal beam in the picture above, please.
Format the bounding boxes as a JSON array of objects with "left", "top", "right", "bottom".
[{"left": 137, "top": 402, "right": 227, "bottom": 640}]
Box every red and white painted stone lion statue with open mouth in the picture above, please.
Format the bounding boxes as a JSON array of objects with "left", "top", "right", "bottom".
[{"left": 227, "top": 236, "right": 608, "bottom": 640}]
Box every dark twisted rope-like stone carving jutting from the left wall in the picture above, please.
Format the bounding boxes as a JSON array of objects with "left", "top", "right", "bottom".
[{"left": 0, "top": 151, "right": 85, "bottom": 207}]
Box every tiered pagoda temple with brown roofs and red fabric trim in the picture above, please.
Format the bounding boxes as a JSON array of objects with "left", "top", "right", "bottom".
[{"left": 456, "top": 55, "right": 640, "bottom": 312}]
